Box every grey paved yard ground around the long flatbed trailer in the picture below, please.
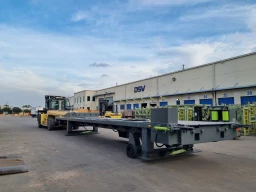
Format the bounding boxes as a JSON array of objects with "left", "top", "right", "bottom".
[{"left": 0, "top": 116, "right": 256, "bottom": 192}]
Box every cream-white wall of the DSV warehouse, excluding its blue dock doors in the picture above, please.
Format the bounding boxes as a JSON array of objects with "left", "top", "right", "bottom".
[{"left": 88, "top": 53, "right": 256, "bottom": 109}]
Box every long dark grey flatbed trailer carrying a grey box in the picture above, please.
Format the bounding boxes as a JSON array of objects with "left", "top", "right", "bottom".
[{"left": 56, "top": 108, "right": 243, "bottom": 160}]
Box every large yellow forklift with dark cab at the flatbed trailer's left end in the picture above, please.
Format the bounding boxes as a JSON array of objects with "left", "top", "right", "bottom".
[{"left": 37, "top": 95, "right": 70, "bottom": 131}]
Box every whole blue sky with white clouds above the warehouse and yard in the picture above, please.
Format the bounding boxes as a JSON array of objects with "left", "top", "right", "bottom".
[{"left": 0, "top": 0, "right": 256, "bottom": 106}]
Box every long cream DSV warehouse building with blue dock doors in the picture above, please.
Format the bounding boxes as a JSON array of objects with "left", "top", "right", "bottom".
[{"left": 70, "top": 52, "right": 256, "bottom": 111}]
